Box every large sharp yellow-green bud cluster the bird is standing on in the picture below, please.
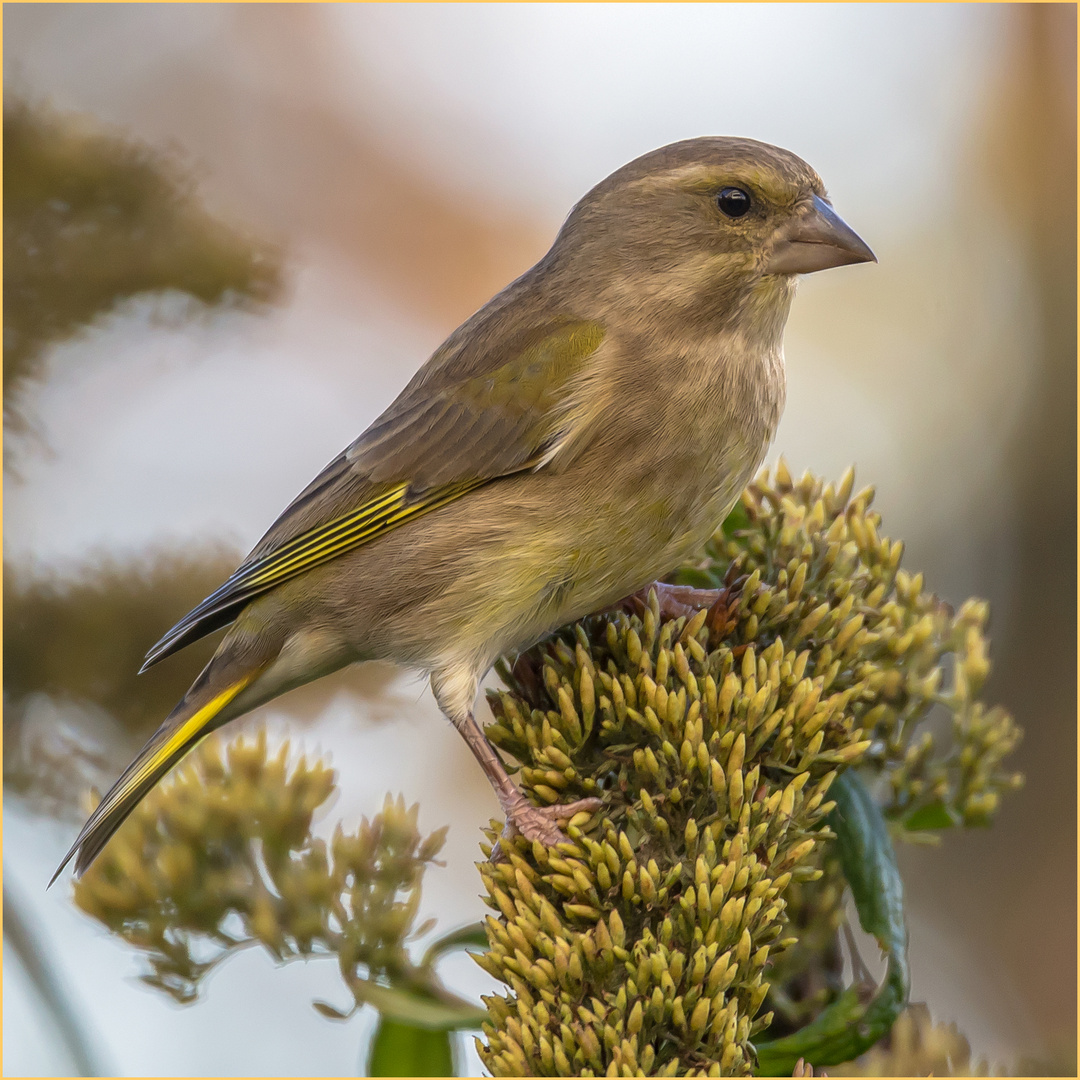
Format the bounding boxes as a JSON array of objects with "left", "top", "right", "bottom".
[{"left": 481, "top": 464, "right": 1018, "bottom": 1076}]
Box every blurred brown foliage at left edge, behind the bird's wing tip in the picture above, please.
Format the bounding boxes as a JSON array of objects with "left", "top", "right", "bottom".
[{"left": 3, "top": 548, "right": 238, "bottom": 810}]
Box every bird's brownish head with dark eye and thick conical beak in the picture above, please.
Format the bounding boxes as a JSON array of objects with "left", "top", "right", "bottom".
[{"left": 551, "top": 136, "right": 875, "bottom": 325}]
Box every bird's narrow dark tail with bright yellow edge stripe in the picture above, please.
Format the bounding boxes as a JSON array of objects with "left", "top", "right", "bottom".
[{"left": 49, "top": 661, "right": 260, "bottom": 885}]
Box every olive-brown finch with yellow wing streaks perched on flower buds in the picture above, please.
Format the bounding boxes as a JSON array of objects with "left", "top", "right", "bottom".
[{"left": 53, "top": 136, "right": 877, "bottom": 881}]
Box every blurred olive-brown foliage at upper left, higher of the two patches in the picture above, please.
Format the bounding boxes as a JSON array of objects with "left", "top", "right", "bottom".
[{"left": 3, "top": 95, "right": 281, "bottom": 429}]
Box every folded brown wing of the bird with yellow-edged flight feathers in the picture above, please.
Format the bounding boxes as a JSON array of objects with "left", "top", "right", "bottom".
[{"left": 143, "top": 320, "right": 604, "bottom": 671}]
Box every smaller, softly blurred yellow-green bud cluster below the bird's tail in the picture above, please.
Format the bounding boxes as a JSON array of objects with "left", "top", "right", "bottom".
[{"left": 75, "top": 732, "right": 460, "bottom": 1016}]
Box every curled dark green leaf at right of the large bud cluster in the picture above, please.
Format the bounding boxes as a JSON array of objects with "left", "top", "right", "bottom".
[{"left": 756, "top": 770, "right": 910, "bottom": 1076}]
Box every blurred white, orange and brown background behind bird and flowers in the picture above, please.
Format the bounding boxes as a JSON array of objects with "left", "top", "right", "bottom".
[{"left": 3, "top": 4, "right": 1077, "bottom": 1076}]
